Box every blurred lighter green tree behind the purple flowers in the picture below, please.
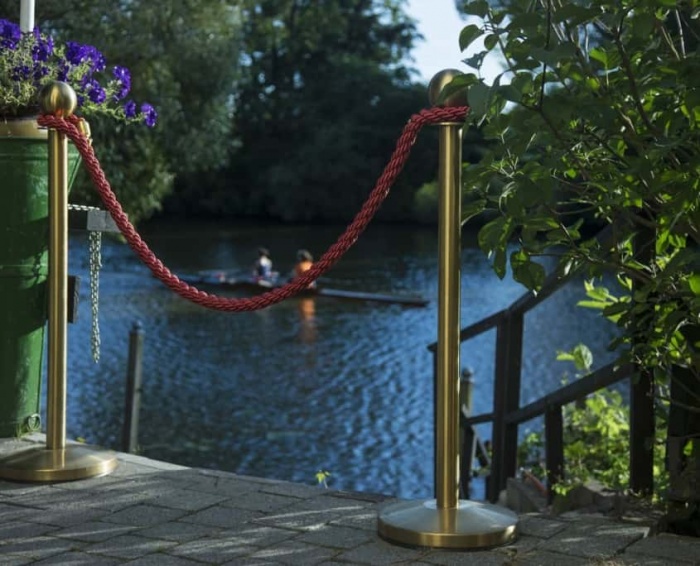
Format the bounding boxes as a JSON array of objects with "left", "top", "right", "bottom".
[{"left": 2, "top": 0, "right": 246, "bottom": 221}]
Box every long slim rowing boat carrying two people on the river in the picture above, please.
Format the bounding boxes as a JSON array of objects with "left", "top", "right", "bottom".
[{"left": 179, "top": 271, "right": 430, "bottom": 307}]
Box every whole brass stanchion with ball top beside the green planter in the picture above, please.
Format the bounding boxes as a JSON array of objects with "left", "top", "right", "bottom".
[{"left": 0, "top": 82, "right": 117, "bottom": 482}]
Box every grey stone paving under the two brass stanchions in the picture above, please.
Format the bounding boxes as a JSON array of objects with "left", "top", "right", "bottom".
[{"left": 0, "top": 437, "right": 700, "bottom": 566}]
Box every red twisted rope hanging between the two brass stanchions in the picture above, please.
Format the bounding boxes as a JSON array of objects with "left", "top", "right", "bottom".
[{"left": 37, "top": 107, "right": 468, "bottom": 312}]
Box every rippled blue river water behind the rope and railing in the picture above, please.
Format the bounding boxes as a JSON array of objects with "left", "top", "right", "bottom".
[{"left": 58, "top": 222, "right": 613, "bottom": 499}]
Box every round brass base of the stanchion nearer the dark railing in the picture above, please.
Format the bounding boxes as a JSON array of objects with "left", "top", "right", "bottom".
[{"left": 377, "top": 499, "right": 518, "bottom": 549}]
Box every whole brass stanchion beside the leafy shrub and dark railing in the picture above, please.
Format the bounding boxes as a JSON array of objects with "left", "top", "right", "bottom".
[{"left": 378, "top": 70, "right": 518, "bottom": 549}]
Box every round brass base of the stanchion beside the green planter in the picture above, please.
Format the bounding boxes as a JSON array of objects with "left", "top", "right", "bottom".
[{"left": 0, "top": 444, "right": 117, "bottom": 482}]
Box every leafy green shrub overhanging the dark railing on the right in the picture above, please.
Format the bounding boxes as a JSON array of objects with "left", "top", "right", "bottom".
[{"left": 451, "top": 0, "right": 700, "bottom": 398}]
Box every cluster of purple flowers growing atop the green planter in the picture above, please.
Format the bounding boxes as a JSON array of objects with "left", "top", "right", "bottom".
[{"left": 0, "top": 19, "right": 157, "bottom": 127}]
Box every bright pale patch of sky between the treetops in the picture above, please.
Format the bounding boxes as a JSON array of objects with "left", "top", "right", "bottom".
[{"left": 406, "top": 0, "right": 501, "bottom": 82}]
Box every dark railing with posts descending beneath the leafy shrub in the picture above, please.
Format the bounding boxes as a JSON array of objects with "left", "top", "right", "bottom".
[{"left": 428, "top": 242, "right": 654, "bottom": 502}]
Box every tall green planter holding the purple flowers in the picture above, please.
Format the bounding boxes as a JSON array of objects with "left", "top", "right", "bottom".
[{"left": 0, "top": 120, "right": 80, "bottom": 438}]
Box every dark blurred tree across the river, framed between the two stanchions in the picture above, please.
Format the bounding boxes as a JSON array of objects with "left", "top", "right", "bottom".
[{"left": 194, "top": 0, "right": 442, "bottom": 221}]
